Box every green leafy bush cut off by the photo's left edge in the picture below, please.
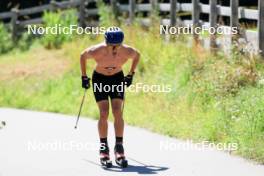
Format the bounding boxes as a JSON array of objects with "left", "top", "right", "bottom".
[{"left": 0, "top": 23, "right": 12, "bottom": 54}]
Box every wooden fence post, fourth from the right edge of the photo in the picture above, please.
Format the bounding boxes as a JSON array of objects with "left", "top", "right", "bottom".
[{"left": 192, "top": 0, "right": 200, "bottom": 44}]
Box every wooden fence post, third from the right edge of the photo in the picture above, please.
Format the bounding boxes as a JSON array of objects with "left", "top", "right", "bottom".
[{"left": 209, "top": 0, "right": 217, "bottom": 51}]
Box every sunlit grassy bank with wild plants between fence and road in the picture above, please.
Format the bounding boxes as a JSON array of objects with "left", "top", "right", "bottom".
[{"left": 0, "top": 26, "right": 264, "bottom": 163}]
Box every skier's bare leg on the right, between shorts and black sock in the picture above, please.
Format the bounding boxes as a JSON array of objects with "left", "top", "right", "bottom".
[{"left": 111, "top": 98, "right": 124, "bottom": 140}]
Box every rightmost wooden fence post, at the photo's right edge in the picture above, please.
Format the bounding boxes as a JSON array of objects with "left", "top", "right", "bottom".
[{"left": 258, "top": 0, "right": 264, "bottom": 57}]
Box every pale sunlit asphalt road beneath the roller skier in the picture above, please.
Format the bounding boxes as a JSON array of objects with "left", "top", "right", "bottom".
[{"left": 0, "top": 108, "right": 264, "bottom": 176}]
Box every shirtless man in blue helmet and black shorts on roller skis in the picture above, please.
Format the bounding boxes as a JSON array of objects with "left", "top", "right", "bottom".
[{"left": 80, "top": 27, "right": 140, "bottom": 167}]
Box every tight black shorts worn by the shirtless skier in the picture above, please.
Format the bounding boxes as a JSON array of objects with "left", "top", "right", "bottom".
[{"left": 92, "top": 71, "right": 124, "bottom": 102}]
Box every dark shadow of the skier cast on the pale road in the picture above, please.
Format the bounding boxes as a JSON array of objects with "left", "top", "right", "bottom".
[{"left": 84, "top": 158, "right": 169, "bottom": 174}]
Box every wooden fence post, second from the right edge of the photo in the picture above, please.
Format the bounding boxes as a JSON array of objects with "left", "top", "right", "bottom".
[{"left": 230, "top": 0, "right": 239, "bottom": 42}]
